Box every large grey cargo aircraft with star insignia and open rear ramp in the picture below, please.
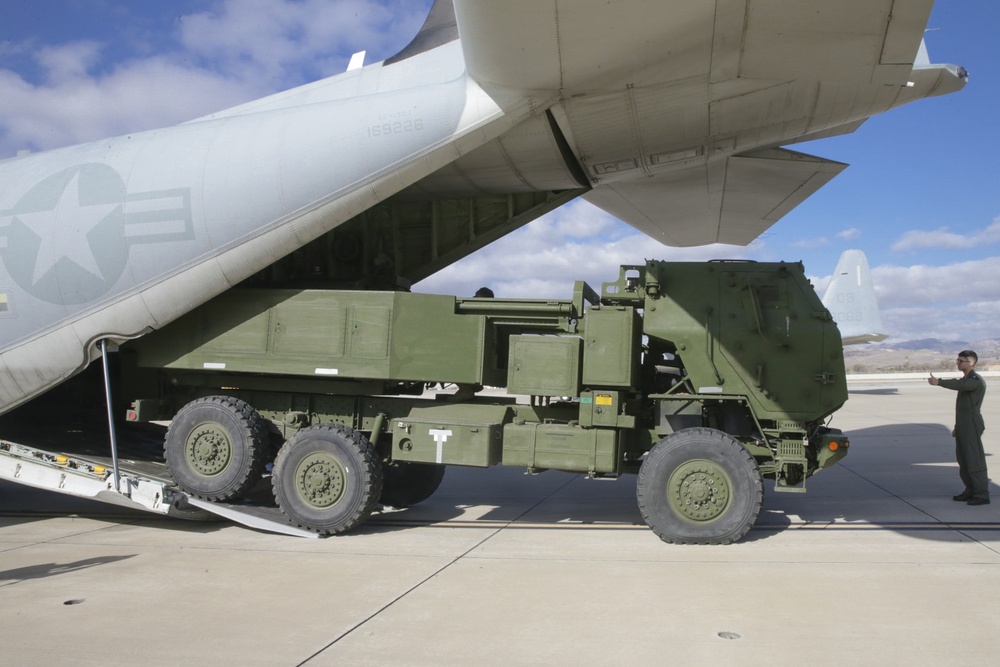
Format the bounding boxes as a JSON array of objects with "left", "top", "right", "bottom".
[{"left": 0, "top": 0, "right": 967, "bottom": 412}]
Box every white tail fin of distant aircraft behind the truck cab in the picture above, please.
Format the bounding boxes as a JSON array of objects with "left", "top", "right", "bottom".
[{"left": 823, "top": 250, "right": 888, "bottom": 345}]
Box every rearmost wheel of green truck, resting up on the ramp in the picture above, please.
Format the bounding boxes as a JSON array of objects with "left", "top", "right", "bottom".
[{"left": 163, "top": 396, "right": 268, "bottom": 502}]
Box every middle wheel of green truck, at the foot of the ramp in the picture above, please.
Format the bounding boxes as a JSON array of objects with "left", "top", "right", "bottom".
[{"left": 271, "top": 424, "right": 382, "bottom": 535}]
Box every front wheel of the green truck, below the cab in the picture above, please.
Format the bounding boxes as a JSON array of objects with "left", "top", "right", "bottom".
[{"left": 636, "top": 428, "right": 764, "bottom": 544}]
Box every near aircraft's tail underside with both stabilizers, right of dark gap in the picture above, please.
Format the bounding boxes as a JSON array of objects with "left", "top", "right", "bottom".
[{"left": 456, "top": 0, "right": 964, "bottom": 246}]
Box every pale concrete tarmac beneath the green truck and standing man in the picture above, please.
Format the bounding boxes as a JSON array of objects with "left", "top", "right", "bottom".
[{"left": 0, "top": 381, "right": 1000, "bottom": 667}]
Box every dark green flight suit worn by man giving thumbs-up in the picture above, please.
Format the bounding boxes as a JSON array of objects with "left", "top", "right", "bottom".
[{"left": 938, "top": 371, "right": 990, "bottom": 498}]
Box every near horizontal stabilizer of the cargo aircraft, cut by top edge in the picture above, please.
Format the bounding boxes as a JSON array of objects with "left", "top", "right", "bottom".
[{"left": 455, "top": 0, "right": 948, "bottom": 94}]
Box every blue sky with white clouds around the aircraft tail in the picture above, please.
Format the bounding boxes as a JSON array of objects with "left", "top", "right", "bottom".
[{"left": 0, "top": 0, "right": 1000, "bottom": 342}]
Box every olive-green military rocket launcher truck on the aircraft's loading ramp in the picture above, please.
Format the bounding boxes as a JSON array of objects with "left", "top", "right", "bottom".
[{"left": 121, "top": 261, "right": 849, "bottom": 544}]
